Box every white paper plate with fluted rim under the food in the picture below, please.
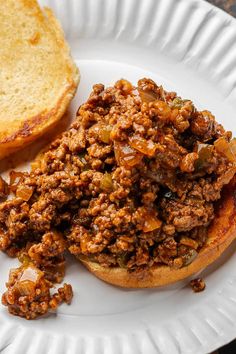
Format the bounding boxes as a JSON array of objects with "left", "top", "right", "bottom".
[{"left": 0, "top": 0, "right": 236, "bottom": 354}]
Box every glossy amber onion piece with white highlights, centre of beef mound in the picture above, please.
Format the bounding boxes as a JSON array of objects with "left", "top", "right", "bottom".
[{"left": 114, "top": 142, "right": 143, "bottom": 167}]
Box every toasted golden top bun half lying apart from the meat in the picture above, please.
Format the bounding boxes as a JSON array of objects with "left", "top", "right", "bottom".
[{"left": 0, "top": 0, "right": 79, "bottom": 158}]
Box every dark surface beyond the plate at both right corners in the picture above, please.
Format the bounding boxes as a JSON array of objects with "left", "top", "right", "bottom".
[{"left": 208, "top": 0, "right": 236, "bottom": 354}]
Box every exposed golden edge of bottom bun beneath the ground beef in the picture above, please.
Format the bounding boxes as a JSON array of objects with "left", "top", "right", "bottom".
[{"left": 80, "top": 177, "right": 236, "bottom": 288}]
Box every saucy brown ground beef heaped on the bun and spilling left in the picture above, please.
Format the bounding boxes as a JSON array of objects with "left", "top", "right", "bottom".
[{"left": 0, "top": 79, "right": 236, "bottom": 318}]
